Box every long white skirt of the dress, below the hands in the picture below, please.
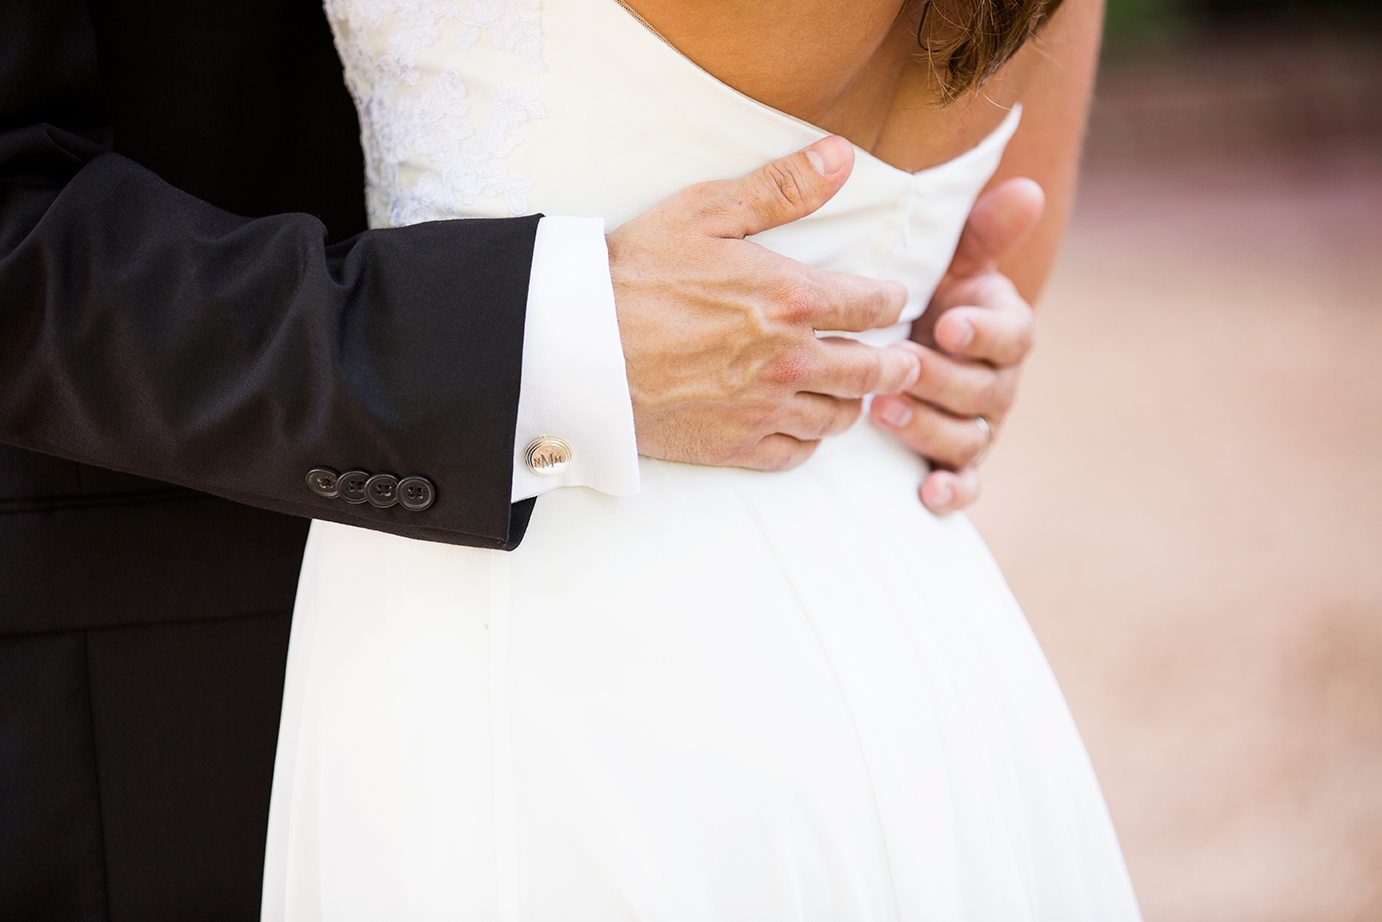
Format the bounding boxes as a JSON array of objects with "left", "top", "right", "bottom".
[{"left": 264, "top": 422, "right": 1137, "bottom": 922}]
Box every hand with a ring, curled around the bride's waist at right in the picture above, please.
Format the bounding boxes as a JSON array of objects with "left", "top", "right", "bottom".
[{"left": 869, "top": 180, "right": 1046, "bottom": 513}]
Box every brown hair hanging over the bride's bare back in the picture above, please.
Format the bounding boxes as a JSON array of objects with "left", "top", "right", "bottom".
[{"left": 908, "top": 0, "right": 1061, "bottom": 102}]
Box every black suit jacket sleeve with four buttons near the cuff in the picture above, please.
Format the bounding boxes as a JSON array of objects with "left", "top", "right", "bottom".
[{"left": 0, "top": 0, "right": 538, "bottom": 547}]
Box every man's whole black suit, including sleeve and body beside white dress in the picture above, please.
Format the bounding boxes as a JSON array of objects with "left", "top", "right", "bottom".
[{"left": 0, "top": 0, "right": 547, "bottom": 919}]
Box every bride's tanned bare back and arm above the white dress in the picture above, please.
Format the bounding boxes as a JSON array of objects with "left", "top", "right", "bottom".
[{"left": 619, "top": 0, "right": 1103, "bottom": 297}]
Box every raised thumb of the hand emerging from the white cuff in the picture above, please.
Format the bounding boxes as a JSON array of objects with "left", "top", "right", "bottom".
[{"left": 716, "top": 135, "right": 854, "bottom": 236}]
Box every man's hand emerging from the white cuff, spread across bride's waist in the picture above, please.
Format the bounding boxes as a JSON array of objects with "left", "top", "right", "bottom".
[{"left": 608, "top": 137, "right": 922, "bottom": 470}]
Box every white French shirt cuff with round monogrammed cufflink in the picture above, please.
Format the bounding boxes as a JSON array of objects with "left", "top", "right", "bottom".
[{"left": 513, "top": 217, "right": 638, "bottom": 502}]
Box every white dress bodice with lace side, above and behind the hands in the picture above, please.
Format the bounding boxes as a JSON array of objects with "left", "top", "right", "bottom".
[{"left": 326, "top": 0, "right": 1019, "bottom": 344}]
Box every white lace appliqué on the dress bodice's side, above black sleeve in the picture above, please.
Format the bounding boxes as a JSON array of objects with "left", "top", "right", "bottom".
[{"left": 325, "top": 0, "right": 546, "bottom": 227}]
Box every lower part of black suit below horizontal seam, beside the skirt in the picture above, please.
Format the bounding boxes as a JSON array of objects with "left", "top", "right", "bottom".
[{"left": 0, "top": 611, "right": 292, "bottom": 922}]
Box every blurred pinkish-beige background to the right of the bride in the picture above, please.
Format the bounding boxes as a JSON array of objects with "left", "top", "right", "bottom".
[{"left": 973, "top": 0, "right": 1382, "bottom": 922}]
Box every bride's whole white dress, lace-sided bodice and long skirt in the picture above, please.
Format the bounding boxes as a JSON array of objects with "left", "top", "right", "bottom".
[{"left": 264, "top": 0, "right": 1137, "bottom": 922}]
